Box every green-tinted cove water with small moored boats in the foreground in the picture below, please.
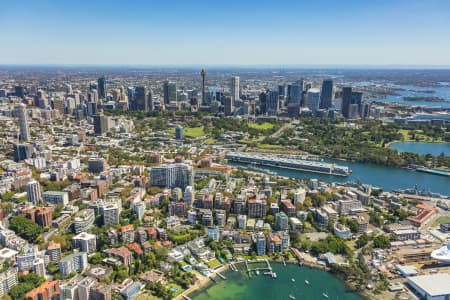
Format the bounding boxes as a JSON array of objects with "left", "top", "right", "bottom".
[{"left": 189, "top": 263, "right": 363, "bottom": 300}]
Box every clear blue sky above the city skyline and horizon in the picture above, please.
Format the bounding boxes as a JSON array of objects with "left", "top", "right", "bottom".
[{"left": 0, "top": 0, "right": 450, "bottom": 66}]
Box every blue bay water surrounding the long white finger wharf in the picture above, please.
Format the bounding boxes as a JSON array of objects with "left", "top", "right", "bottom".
[{"left": 229, "top": 159, "right": 450, "bottom": 196}]
